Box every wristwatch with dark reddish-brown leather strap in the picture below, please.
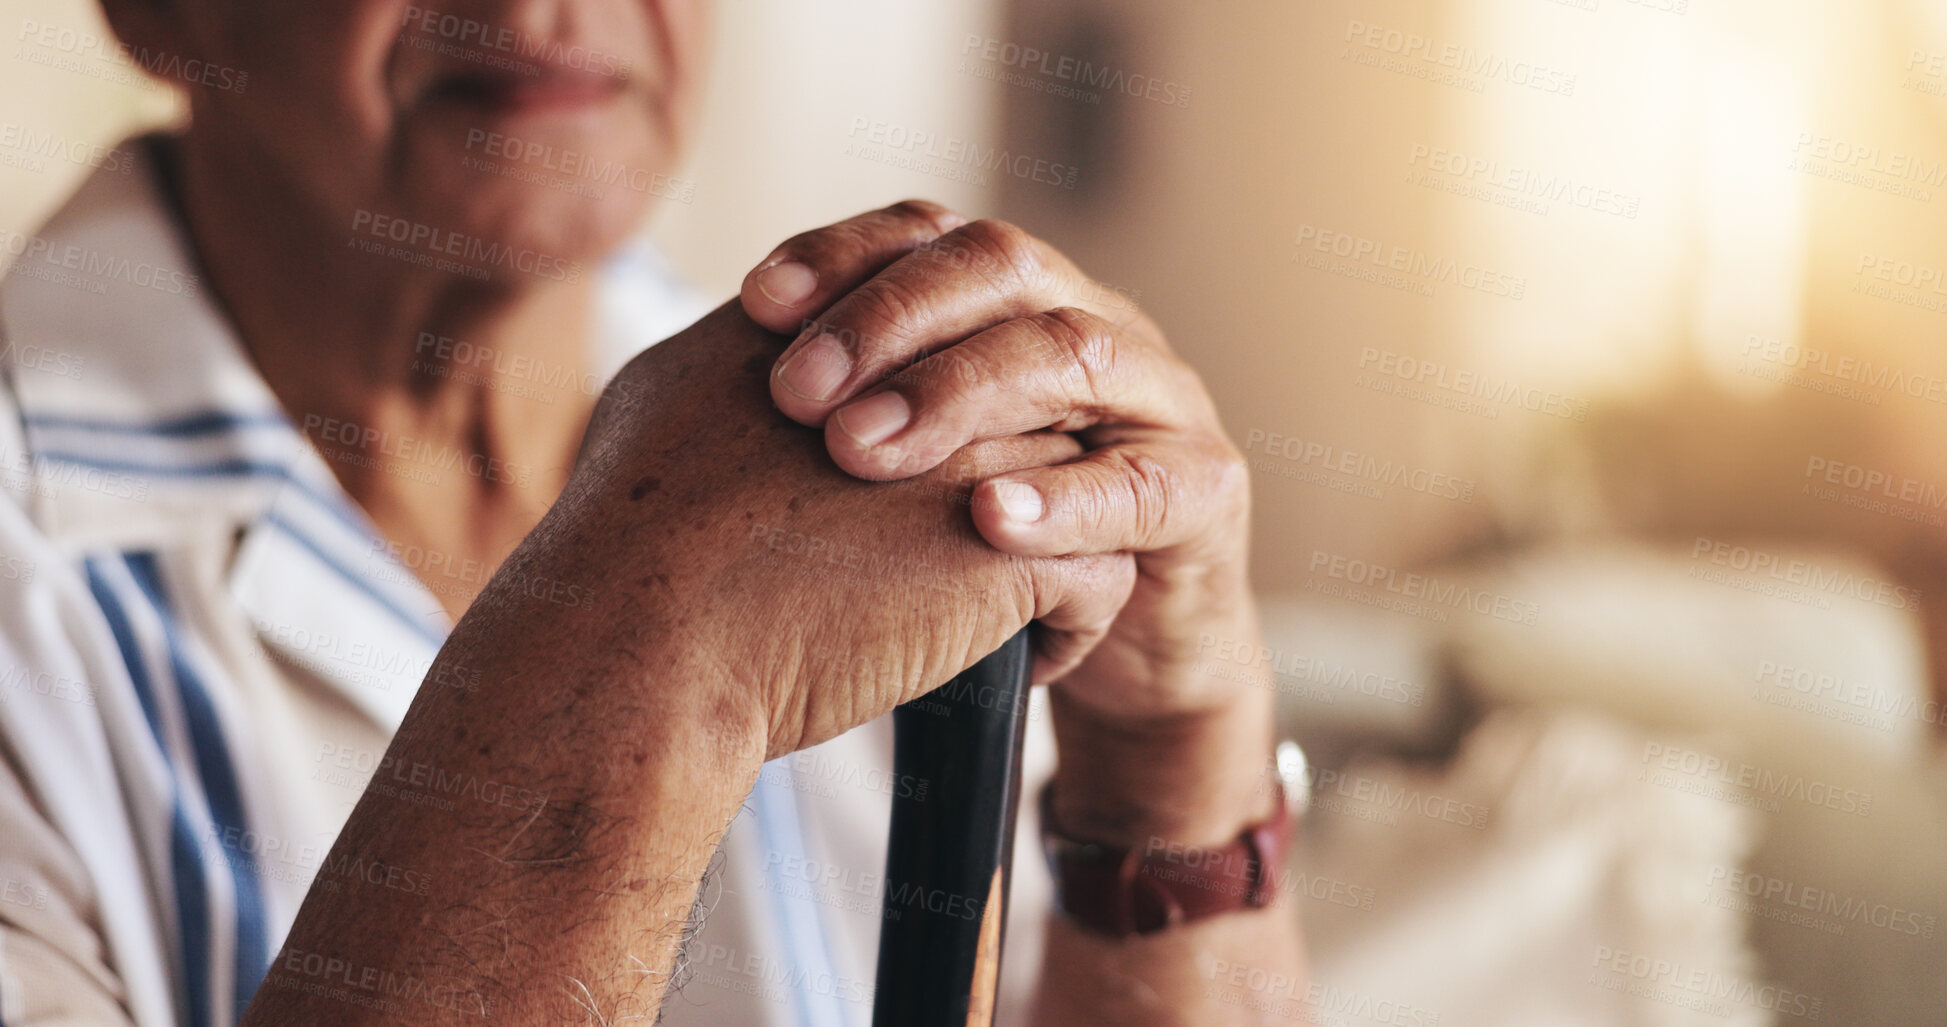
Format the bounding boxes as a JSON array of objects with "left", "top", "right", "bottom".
[{"left": 1042, "top": 742, "right": 1310, "bottom": 937}]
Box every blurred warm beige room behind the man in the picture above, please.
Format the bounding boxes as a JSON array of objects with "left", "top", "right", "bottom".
[{"left": 11, "top": 0, "right": 1947, "bottom": 1025}]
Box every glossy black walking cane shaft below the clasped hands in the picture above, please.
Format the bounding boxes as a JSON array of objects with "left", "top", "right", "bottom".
[{"left": 872, "top": 628, "right": 1032, "bottom": 1027}]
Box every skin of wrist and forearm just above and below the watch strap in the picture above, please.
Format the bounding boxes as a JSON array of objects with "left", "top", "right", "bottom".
[{"left": 1036, "top": 623, "right": 1304, "bottom": 1025}]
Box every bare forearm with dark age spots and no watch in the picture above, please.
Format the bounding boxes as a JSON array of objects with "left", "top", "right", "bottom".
[{"left": 245, "top": 553, "right": 763, "bottom": 1027}]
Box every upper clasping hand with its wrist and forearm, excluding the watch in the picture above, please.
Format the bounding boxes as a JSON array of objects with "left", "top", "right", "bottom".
[{"left": 742, "top": 203, "right": 1304, "bottom": 1025}]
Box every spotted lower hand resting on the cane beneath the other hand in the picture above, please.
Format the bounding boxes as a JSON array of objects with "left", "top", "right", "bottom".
[{"left": 545, "top": 302, "right": 1133, "bottom": 758}]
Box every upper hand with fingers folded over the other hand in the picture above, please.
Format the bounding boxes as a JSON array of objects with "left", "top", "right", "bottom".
[{"left": 742, "top": 201, "right": 1267, "bottom": 748}]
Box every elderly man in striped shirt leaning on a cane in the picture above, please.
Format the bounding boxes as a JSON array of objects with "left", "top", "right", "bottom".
[{"left": 0, "top": 0, "right": 1303, "bottom": 1027}]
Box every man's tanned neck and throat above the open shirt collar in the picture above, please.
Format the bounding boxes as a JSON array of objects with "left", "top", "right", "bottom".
[{"left": 162, "top": 128, "right": 598, "bottom": 612}]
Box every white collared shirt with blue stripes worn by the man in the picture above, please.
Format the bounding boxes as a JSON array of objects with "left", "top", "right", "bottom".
[{"left": 0, "top": 149, "right": 1051, "bottom": 1027}]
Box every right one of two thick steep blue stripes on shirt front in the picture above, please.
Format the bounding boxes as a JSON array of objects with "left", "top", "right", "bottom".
[{"left": 123, "top": 553, "right": 271, "bottom": 1017}]
